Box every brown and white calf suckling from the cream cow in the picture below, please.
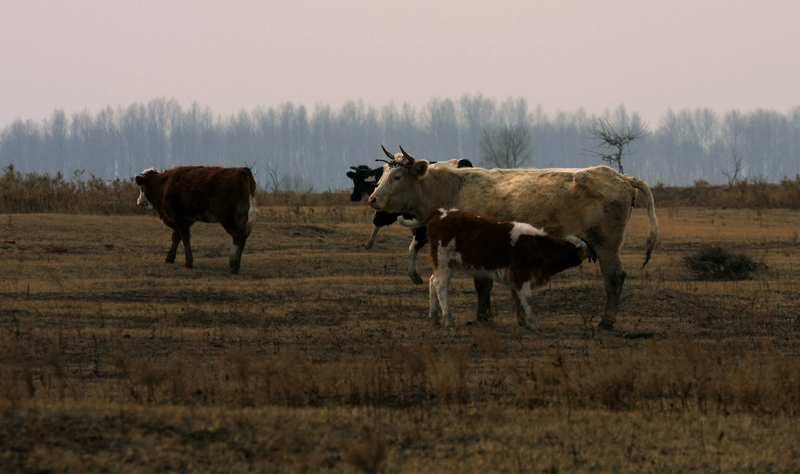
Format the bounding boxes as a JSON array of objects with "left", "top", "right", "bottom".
[{"left": 401, "top": 209, "right": 590, "bottom": 328}]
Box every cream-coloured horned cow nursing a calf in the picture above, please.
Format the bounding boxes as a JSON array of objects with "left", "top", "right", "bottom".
[{"left": 369, "top": 148, "right": 658, "bottom": 329}]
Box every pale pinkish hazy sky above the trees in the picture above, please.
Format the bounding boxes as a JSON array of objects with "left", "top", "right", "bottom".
[{"left": 0, "top": 0, "right": 800, "bottom": 127}]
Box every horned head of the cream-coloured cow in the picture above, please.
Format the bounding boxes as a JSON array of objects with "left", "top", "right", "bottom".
[{"left": 369, "top": 146, "right": 429, "bottom": 212}]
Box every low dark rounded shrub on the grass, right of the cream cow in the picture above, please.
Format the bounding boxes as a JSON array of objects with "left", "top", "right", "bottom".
[{"left": 683, "top": 245, "right": 767, "bottom": 281}]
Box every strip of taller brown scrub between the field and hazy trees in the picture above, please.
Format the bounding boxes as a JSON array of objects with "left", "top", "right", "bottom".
[{"left": 0, "top": 165, "right": 800, "bottom": 215}]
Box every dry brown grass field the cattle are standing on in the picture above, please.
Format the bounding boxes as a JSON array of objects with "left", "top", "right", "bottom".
[{"left": 0, "top": 199, "right": 800, "bottom": 473}]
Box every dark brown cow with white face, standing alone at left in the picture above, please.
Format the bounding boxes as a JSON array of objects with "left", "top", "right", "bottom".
[{"left": 135, "top": 166, "right": 257, "bottom": 273}]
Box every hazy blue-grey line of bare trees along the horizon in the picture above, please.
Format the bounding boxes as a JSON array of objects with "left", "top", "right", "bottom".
[{"left": 0, "top": 94, "right": 800, "bottom": 191}]
